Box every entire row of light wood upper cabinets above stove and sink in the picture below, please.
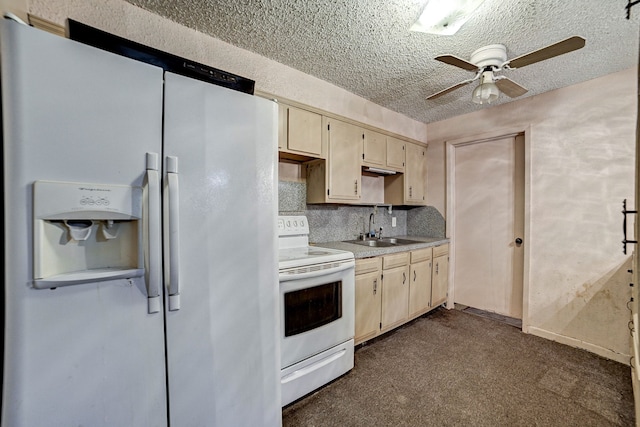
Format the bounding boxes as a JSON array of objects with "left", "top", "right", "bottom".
[{"left": 278, "top": 102, "right": 427, "bottom": 206}]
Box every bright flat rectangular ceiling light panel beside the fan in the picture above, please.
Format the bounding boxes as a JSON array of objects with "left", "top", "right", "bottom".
[{"left": 409, "top": 0, "right": 484, "bottom": 36}]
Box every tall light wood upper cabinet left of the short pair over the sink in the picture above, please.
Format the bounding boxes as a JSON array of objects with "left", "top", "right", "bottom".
[{"left": 306, "top": 117, "right": 362, "bottom": 203}]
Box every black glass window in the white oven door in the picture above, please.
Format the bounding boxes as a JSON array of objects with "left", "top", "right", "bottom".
[{"left": 284, "top": 281, "right": 342, "bottom": 337}]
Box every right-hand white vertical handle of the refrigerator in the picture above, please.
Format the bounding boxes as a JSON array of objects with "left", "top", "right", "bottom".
[{"left": 167, "top": 156, "right": 180, "bottom": 311}]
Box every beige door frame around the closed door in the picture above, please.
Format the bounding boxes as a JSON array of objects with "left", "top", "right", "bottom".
[{"left": 444, "top": 126, "right": 531, "bottom": 333}]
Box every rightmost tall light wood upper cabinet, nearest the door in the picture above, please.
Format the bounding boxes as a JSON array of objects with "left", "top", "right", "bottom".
[{"left": 384, "top": 142, "right": 427, "bottom": 206}]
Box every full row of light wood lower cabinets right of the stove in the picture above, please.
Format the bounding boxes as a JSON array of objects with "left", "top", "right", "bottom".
[{"left": 355, "top": 244, "right": 449, "bottom": 344}]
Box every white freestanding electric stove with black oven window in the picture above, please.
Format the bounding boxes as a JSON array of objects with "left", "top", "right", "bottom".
[{"left": 278, "top": 216, "right": 355, "bottom": 406}]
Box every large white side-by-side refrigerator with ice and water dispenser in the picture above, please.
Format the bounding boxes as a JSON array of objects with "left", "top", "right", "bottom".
[{"left": 0, "top": 20, "right": 282, "bottom": 427}]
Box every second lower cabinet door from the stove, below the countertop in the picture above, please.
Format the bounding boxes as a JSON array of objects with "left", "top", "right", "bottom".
[{"left": 382, "top": 266, "right": 409, "bottom": 331}]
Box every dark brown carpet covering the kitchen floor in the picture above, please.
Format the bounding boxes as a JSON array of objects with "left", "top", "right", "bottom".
[{"left": 283, "top": 308, "right": 635, "bottom": 427}]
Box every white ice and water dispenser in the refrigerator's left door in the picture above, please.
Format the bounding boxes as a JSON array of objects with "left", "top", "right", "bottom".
[{"left": 33, "top": 181, "right": 145, "bottom": 289}]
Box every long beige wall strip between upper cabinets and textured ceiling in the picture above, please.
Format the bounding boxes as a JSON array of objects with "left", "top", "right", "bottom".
[{"left": 23, "top": 0, "right": 427, "bottom": 142}]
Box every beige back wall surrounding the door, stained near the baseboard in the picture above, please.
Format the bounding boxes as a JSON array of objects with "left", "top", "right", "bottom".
[{"left": 427, "top": 69, "right": 637, "bottom": 363}]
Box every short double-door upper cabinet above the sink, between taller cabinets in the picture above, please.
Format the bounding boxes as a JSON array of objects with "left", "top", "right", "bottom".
[{"left": 362, "top": 129, "right": 405, "bottom": 172}]
